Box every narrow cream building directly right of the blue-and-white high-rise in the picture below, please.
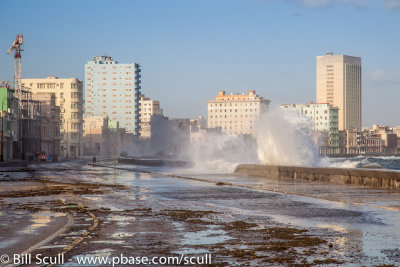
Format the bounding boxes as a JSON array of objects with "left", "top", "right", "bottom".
[{"left": 140, "top": 95, "right": 163, "bottom": 139}]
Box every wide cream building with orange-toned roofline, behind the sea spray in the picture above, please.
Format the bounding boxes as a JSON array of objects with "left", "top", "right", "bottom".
[{"left": 207, "top": 90, "right": 270, "bottom": 134}]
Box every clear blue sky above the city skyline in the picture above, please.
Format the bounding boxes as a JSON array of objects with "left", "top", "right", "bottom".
[{"left": 0, "top": 0, "right": 400, "bottom": 126}]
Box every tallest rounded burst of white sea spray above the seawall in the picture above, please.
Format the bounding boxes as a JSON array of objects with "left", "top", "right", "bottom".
[{"left": 254, "top": 110, "right": 318, "bottom": 166}]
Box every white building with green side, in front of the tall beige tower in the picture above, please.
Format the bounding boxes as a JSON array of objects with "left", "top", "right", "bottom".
[{"left": 281, "top": 103, "right": 339, "bottom": 150}]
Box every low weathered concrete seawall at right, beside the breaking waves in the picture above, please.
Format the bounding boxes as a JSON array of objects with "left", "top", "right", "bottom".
[{"left": 235, "top": 164, "right": 400, "bottom": 189}]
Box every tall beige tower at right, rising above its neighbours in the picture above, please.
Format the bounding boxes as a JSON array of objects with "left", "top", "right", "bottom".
[{"left": 317, "top": 53, "right": 361, "bottom": 130}]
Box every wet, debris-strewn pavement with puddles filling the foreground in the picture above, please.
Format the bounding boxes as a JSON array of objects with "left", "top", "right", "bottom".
[{"left": 0, "top": 162, "right": 400, "bottom": 266}]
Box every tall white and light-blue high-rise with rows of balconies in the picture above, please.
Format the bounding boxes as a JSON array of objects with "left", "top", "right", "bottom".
[{"left": 85, "top": 56, "right": 141, "bottom": 136}]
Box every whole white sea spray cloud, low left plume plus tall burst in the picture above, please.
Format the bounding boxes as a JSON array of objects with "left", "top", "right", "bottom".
[{"left": 186, "top": 110, "right": 318, "bottom": 171}]
